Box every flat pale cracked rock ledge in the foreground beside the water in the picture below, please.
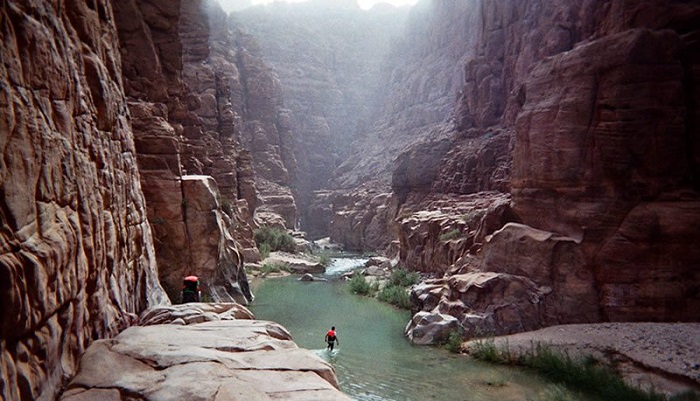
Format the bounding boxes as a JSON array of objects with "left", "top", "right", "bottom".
[{"left": 60, "top": 304, "right": 351, "bottom": 401}]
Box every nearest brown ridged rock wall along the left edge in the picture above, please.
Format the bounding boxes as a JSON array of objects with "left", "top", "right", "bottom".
[{"left": 0, "top": 1, "right": 167, "bottom": 400}]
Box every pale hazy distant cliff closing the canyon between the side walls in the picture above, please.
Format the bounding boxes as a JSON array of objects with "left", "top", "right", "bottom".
[{"left": 231, "top": 0, "right": 408, "bottom": 238}]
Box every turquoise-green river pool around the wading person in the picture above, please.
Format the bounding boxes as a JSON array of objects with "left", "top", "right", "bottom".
[{"left": 251, "top": 260, "right": 568, "bottom": 401}]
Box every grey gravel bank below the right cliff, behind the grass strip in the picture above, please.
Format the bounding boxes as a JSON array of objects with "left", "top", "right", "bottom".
[{"left": 464, "top": 323, "right": 700, "bottom": 394}]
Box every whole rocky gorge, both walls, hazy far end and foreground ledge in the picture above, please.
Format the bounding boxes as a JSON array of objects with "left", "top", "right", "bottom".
[{"left": 0, "top": 0, "right": 700, "bottom": 401}]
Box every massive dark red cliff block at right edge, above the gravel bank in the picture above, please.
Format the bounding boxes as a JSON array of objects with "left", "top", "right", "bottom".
[{"left": 513, "top": 9, "right": 700, "bottom": 320}]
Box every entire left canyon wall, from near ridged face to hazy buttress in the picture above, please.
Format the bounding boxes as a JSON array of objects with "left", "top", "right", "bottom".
[{"left": 0, "top": 0, "right": 297, "bottom": 400}]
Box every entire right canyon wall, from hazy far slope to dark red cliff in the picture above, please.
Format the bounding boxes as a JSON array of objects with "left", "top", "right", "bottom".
[{"left": 234, "top": 0, "right": 700, "bottom": 333}]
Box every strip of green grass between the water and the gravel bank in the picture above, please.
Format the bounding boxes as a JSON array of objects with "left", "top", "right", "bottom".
[{"left": 470, "top": 339, "right": 700, "bottom": 401}]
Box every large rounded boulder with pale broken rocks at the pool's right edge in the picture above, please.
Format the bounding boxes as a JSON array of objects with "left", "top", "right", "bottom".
[{"left": 411, "top": 223, "right": 600, "bottom": 337}]
